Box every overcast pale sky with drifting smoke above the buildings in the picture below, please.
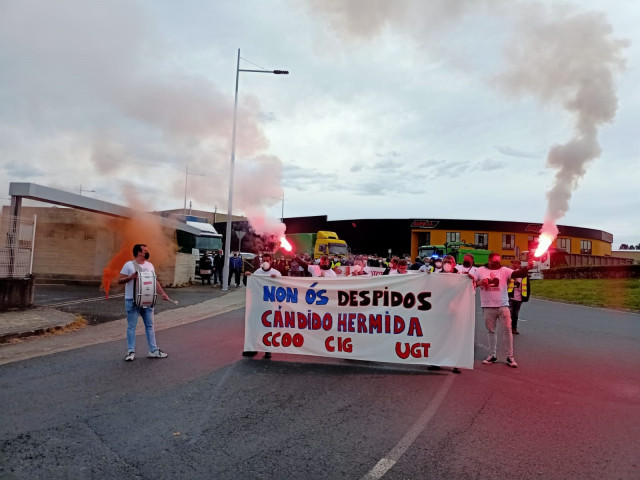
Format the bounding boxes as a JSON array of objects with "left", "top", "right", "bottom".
[{"left": 0, "top": 0, "right": 640, "bottom": 248}]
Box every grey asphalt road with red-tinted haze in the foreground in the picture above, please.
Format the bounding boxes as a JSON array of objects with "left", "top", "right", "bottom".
[{"left": 0, "top": 299, "right": 640, "bottom": 480}]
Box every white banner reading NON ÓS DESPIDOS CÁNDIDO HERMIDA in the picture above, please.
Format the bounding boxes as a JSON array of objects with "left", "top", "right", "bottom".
[{"left": 244, "top": 274, "right": 475, "bottom": 369}]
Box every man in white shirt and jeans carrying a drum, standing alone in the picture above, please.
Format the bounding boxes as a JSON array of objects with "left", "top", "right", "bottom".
[{"left": 118, "top": 243, "right": 169, "bottom": 362}]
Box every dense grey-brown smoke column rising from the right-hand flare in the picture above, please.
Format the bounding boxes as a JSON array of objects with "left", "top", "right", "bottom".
[{"left": 498, "top": 4, "right": 627, "bottom": 237}]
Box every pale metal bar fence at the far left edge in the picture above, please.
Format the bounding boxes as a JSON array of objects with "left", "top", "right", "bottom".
[{"left": 0, "top": 215, "right": 36, "bottom": 278}]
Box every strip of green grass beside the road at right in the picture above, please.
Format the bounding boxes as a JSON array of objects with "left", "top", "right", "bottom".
[{"left": 531, "top": 278, "right": 640, "bottom": 311}]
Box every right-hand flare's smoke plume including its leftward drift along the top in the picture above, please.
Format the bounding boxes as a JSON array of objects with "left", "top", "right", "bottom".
[{"left": 309, "top": 0, "right": 627, "bottom": 238}]
